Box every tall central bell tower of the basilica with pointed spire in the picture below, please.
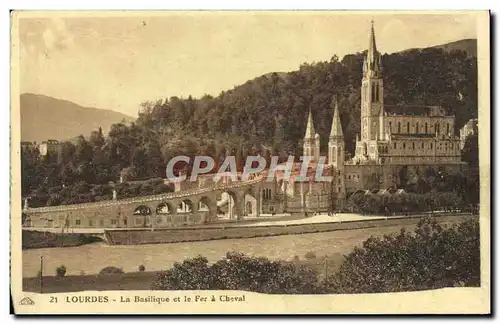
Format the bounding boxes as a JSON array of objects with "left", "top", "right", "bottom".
[{"left": 361, "top": 20, "right": 384, "bottom": 142}]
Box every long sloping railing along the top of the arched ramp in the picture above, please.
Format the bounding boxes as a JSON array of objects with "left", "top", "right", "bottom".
[{"left": 24, "top": 176, "right": 265, "bottom": 213}]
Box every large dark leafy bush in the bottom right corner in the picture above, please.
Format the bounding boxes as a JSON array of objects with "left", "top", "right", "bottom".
[{"left": 328, "top": 218, "right": 480, "bottom": 293}]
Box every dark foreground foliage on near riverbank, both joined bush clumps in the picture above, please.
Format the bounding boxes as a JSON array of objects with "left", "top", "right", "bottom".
[{"left": 152, "top": 219, "right": 480, "bottom": 294}]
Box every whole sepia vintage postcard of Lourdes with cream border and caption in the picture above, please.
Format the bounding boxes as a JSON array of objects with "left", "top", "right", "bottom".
[{"left": 11, "top": 11, "right": 491, "bottom": 315}]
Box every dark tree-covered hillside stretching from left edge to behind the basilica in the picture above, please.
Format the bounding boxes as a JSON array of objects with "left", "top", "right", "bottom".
[{"left": 23, "top": 43, "right": 477, "bottom": 206}]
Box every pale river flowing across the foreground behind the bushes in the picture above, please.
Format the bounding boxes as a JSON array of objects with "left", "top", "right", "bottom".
[{"left": 22, "top": 226, "right": 414, "bottom": 277}]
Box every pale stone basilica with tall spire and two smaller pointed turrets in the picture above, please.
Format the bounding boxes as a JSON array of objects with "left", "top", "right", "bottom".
[{"left": 296, "top": 23, "right": 464, "bottom": 210}]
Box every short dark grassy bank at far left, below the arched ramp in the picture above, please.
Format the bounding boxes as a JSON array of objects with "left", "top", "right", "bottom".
[{"left": 22, "top": 231, "right": 102, "bottom": 250}]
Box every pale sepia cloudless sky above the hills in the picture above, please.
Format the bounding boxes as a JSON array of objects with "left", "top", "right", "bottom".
[{"left": 17, "top": 11, "right": 477, "bottom": 116}]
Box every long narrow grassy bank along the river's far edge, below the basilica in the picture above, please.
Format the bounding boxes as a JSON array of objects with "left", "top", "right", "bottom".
[{"left": 106, "top": 215, "right": 474, "bottom": 245}]
